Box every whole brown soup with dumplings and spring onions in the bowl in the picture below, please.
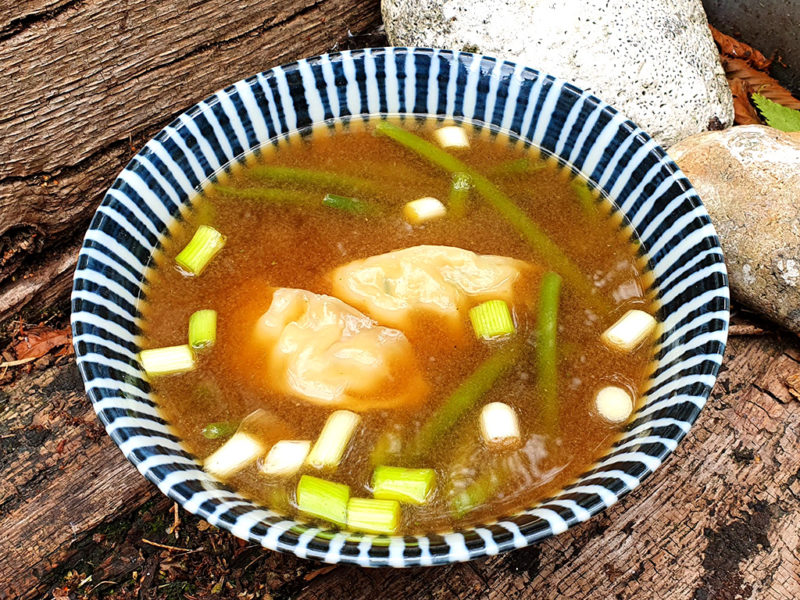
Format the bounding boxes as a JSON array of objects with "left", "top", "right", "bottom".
[{"left": 140, "top": 120, "right": 657, "bottom": 534}]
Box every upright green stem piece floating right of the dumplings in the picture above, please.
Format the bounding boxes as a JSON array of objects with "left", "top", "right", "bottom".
[{"left": 536, "top": 271, "right": 561, "bottom": 433}]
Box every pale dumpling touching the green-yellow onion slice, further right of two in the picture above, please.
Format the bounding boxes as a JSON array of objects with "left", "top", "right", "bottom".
[{"left": 331, "top": 246, "right": 531, "bottom": 329}]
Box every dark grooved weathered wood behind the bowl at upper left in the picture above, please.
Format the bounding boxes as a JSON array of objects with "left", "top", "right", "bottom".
[{"left": 0, "top": 0, "right": 380, "bottom": 323}]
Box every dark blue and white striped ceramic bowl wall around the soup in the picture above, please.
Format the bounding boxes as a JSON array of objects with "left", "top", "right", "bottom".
[{"left": 72, "top": 48, "right": 729, "bottom": 567}]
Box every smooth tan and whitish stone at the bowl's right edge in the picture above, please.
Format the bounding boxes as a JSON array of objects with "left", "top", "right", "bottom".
[{"left": 669, "top": 125, "right": 800, "bottom": 334}]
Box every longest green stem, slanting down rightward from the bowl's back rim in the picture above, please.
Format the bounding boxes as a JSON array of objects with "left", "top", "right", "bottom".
[{"left": 375, "top": 121, "right": 605, "bottom": 309}]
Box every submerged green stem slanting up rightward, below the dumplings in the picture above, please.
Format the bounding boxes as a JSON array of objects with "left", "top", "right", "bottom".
[{"left": 404, "top": 344, "right": 520, "bottom": 463}]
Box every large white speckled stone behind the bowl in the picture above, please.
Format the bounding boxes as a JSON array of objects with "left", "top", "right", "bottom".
[{"left": 382, "top": 0, "right": 733, "bottom": 148}]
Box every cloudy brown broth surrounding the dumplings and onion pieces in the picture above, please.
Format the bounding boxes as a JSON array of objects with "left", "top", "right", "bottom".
[{"left": 141, "top": 121, "right": 652, "bottom": 533}]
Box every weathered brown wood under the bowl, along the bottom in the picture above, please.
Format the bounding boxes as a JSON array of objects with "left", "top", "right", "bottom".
[{"left": 0, "top": 334, "right": 800, "bottom": 600}]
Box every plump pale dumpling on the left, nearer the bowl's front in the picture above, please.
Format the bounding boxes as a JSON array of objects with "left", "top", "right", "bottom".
[{"left": 255, "top": 288, "right": 427, "bottom": 411}]
